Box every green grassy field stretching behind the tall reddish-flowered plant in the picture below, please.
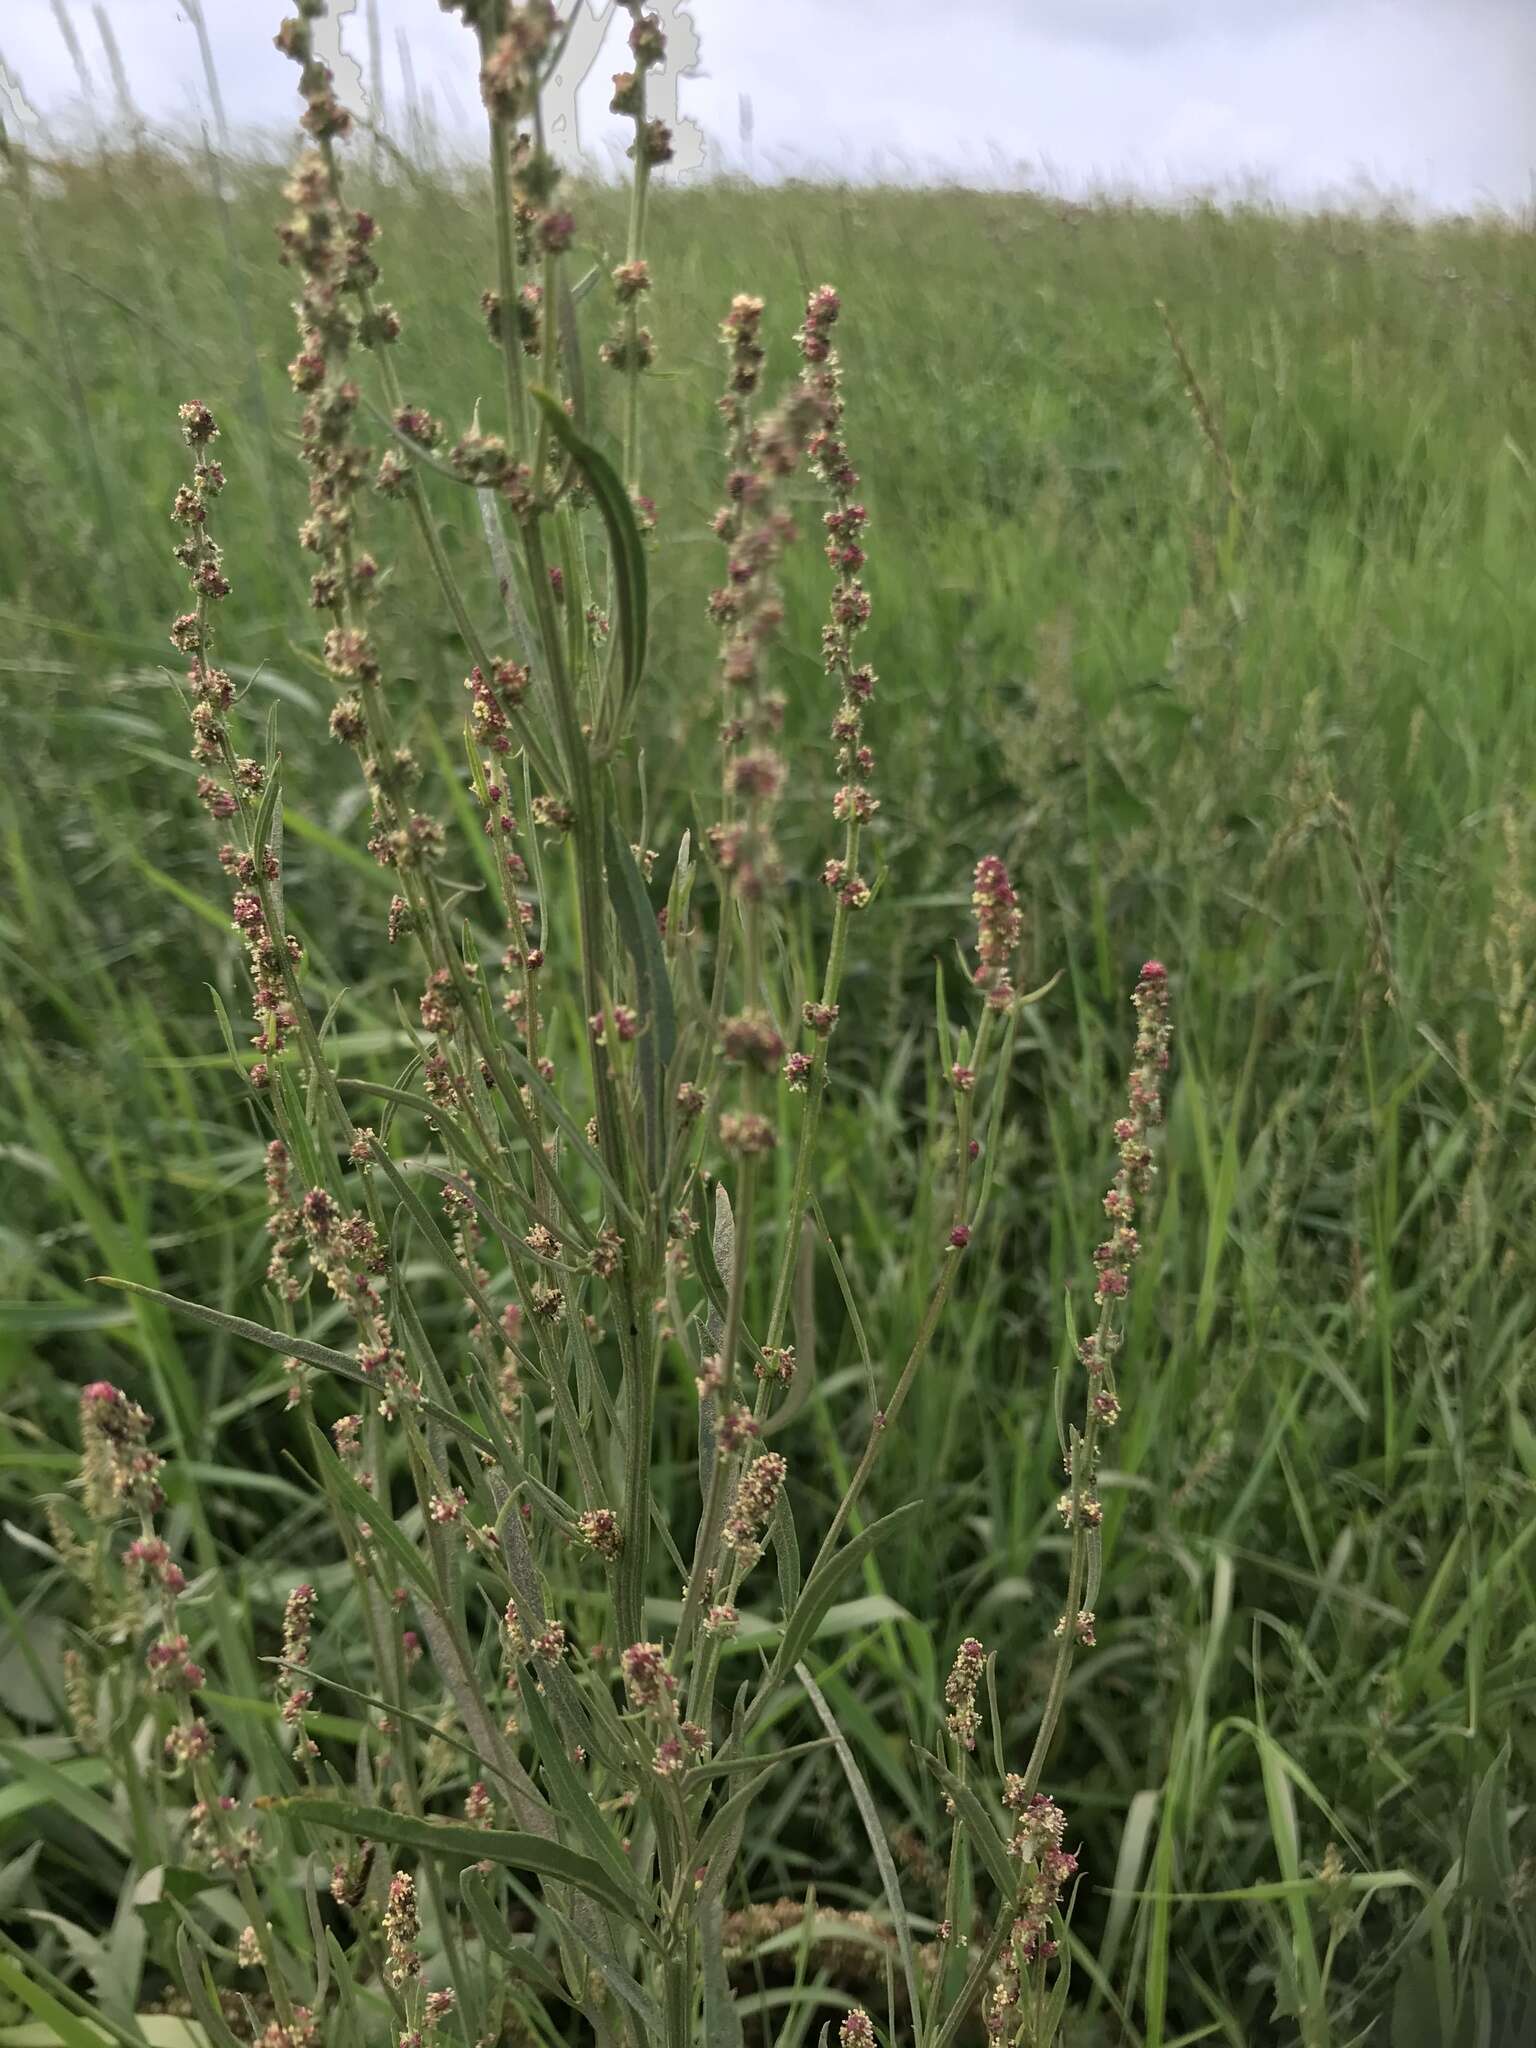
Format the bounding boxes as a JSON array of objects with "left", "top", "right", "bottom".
[{"left": 0, "top": 132, "right": 1536, "bottom": 2048}]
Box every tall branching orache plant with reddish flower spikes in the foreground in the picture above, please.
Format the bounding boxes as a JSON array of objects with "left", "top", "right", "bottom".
[{"left": 53, "top": 0, "right": 1169, "bottom": 2048}]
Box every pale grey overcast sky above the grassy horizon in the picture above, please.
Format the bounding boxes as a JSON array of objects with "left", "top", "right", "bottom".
[{"left": 0, "top": 0, "right": 1536, "bottom": 211}]
